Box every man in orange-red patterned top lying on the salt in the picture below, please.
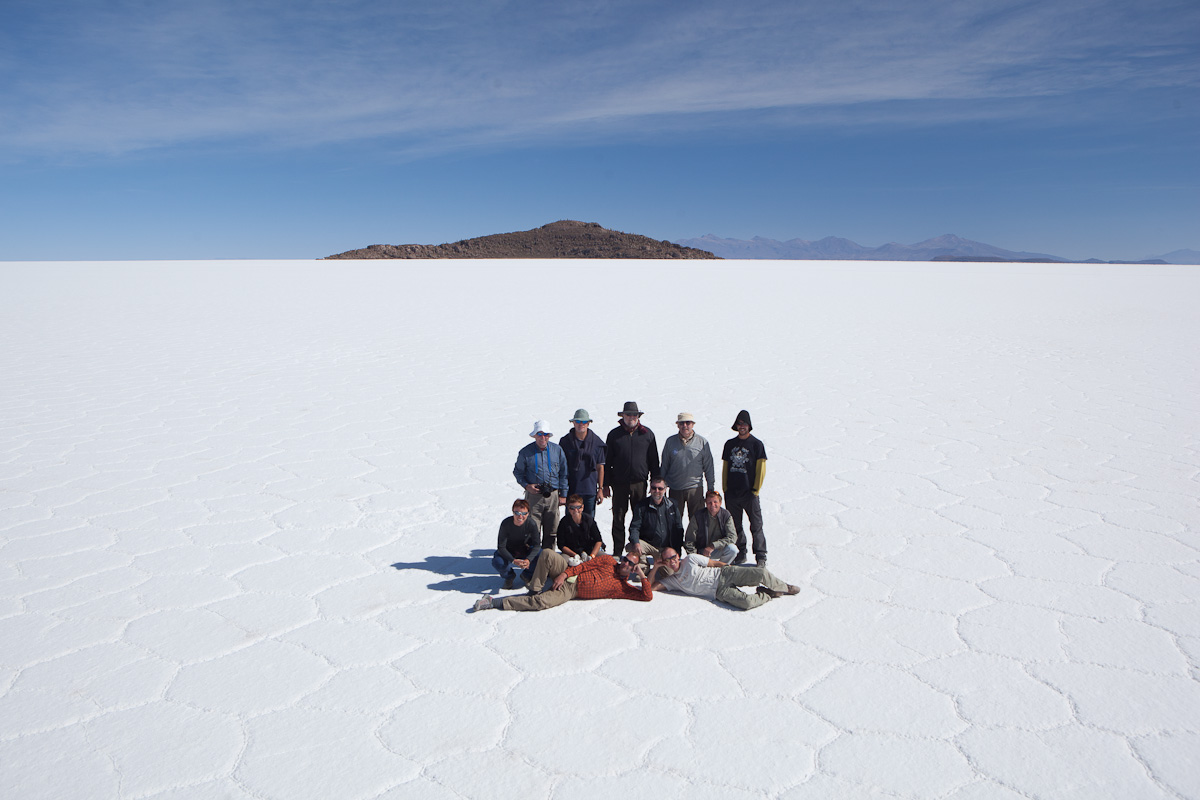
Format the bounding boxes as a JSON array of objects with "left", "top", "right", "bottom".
[{"left": 475, "top": 549, "right": 654, "bottom": 612}]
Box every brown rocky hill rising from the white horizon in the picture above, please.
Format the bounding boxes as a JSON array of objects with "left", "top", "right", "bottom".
[{"left": 326, "top": 219, "right": 718, "bottom": 258}]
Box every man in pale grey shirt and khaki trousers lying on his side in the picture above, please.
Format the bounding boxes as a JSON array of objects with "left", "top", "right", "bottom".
[{"left": 649, "top": 547, "right": 800, "bottom": 610}]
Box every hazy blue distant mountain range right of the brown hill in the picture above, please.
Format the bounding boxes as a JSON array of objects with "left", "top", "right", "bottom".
[{"left": 676, "top": 234, "right": 1200, "bottom": 264}]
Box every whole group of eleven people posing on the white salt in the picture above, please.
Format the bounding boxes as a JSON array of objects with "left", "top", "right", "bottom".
[{"left": 475, "top": 402, "right": 799, "bottom": 610}]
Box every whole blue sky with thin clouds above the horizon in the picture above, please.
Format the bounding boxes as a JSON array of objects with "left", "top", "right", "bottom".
[{"left": 0, "top": 0, "right": 1200, "bottom": 260}]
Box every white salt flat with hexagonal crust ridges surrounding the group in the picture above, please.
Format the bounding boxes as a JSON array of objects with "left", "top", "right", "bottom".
[{"left": 0, "top": 261, "right": 1200, "bottom": 800}]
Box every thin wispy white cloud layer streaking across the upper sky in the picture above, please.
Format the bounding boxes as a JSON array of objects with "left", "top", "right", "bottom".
[{"left": 0, "top": 0, "right": 1200, "bottom": 155}]
